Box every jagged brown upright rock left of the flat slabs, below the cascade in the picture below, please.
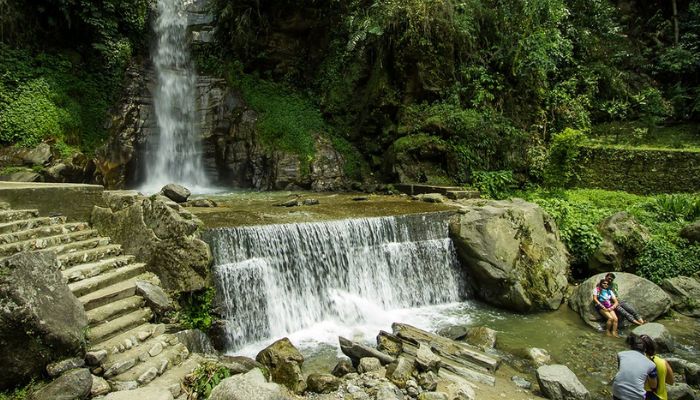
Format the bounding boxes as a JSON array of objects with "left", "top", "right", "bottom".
[{"left": 255, "top": 338, "right": 306, "bottom": 394}]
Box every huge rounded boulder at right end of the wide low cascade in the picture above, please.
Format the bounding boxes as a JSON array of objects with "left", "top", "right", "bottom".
[{"left": 450, "top": 199, "right": 569, "bottom": 312}]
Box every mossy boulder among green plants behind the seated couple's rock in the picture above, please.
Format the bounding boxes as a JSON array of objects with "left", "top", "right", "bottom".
[{"left": 588, "top": 211, "right": 651, "bottom": 272}]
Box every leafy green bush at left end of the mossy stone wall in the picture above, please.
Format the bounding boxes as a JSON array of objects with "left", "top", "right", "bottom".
[{"left": 545, "top": 128, "right": 587, "bottom": 187}]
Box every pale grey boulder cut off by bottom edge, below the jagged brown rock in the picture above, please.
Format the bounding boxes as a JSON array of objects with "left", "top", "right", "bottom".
[{"left": 209, "top": 368, "right": 294, "bottom": 400}]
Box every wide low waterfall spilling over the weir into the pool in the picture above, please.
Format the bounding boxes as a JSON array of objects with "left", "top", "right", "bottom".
[{"left": 205, "top": 213, "right": 465, "bottom": 351}]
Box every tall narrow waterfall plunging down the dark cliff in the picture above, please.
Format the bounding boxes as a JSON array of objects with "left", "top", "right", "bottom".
[{"left": 141, "top": 0, "right": 208, "bottom": 192}]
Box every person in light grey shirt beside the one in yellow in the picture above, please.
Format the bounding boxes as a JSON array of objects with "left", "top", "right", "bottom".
[{"left": 613, "top": 334, "right": 658, "bottom": 400}]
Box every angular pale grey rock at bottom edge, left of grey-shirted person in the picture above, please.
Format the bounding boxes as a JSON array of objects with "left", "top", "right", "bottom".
[{"left": 537, "top": 365, "right": 591, "bottom": 400}]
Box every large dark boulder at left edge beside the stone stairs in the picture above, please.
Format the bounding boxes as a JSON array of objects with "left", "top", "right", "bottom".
[{"left": 0, "top": 252, "right": 89, "bottom": 391}]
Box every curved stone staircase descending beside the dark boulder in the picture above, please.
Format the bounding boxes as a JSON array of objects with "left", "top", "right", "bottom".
[{"left": 0, "top": 210, "right": 200, "bottom": 399}]
